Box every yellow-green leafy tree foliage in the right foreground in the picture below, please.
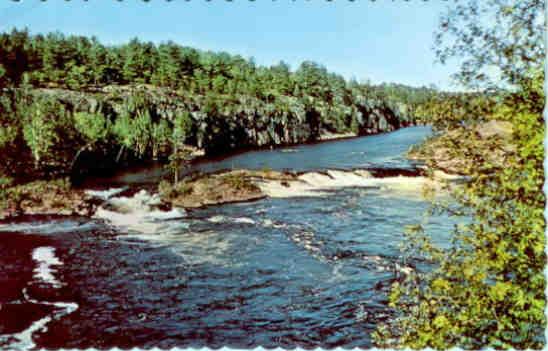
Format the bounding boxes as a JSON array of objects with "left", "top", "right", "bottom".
[{"left": 375, "top": 0, "right": 546, "bottom": 349}]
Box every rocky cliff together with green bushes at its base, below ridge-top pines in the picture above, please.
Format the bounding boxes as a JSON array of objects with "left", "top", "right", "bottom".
[{"left": 0, "top": 85, "right": 413, "bottom": 180}]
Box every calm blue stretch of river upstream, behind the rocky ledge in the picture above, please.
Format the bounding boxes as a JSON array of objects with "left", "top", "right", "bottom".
[{"left": 108, "top": 126, "right": 432, "bottom": 184}]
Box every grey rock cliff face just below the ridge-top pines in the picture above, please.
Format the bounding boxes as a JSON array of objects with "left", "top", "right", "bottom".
[{"left": 33, "top": 86, "right": 414, "bottom": 155}]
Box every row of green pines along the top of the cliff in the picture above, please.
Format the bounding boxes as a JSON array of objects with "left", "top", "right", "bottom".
[{"left": 0, "top": 29, "right": 436, "bottom": 105}]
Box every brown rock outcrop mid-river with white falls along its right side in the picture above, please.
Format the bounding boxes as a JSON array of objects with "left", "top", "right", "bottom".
[{"left": 159, "top": 169, "right": 462, "bottom": 208}]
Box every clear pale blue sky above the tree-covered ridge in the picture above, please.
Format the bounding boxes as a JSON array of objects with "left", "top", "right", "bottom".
[{"left": 0, "top": 0, "right": 462, "bottom": 89}]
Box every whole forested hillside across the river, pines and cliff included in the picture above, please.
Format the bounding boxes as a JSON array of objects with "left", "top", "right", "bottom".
[{"left": 0, "top": 29, "right": 438, "bottom": 183}]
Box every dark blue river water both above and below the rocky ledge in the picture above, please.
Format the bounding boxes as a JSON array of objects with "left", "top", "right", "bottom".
[{"left": 0, "top": 127, "right": 462, "bottom": 349}]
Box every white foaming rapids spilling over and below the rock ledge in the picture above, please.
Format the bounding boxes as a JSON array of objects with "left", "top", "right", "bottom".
[{"left": 85, "top": 170, "right": 460, "bottom": 274}]
